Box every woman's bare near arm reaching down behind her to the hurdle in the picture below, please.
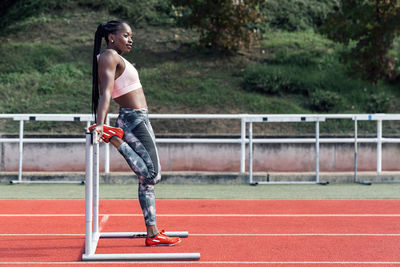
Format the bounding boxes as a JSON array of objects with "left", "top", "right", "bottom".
[{"left": 95, "top": 51, "right": 119, "bottom": 140}]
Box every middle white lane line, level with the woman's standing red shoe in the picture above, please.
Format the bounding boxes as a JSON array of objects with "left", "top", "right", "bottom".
[{"left": 0, "top": 233, "right": 400, "bottom": 237}]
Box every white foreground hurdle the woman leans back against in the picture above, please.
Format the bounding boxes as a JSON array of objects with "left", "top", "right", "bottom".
[{"left": 82, "top": 132, "right": 200, "bottom": 261}]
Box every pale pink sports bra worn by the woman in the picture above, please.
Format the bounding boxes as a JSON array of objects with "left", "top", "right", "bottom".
[{"left": 97, "top": 55, "right": 142, "bottom": 99}]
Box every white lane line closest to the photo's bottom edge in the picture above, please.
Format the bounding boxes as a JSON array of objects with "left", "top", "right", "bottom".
[{"left": 0, "top": 261, "right": 400, "bottom": 266}]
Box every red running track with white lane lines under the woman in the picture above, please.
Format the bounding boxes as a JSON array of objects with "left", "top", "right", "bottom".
[{"left": 0, "top": 200, "right": 400, "bottom": 266}]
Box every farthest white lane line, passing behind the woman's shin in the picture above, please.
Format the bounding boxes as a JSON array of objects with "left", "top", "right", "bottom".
[{"left": 0, "top": 213, "right": 400, "bottom": 217}]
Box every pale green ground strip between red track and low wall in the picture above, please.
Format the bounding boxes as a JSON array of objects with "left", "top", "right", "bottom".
[{"left": 0, "top": 183, "right": 400, "bottom": 199}]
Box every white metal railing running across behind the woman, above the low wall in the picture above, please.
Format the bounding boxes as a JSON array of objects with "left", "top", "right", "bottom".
[{"left": 0, "top": 114, "right": 400, "bottom": 184}]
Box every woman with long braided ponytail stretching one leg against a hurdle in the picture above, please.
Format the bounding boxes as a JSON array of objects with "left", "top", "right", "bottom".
[{"left": 91, "top": 20, "right": 180, "bottom": 246}]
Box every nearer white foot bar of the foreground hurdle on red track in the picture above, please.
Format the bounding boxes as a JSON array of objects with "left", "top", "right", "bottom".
[{"left": 82, "top": 253, "right": 200, "bottom": 261}]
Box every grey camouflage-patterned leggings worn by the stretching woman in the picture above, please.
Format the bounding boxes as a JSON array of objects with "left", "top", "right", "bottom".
[{"left": 116, "top": 108, "right": 161, "bottom": 225}]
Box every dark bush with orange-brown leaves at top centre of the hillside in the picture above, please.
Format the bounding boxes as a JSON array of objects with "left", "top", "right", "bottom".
[{"left": 171, "top": 0, "right": 264, "bottom": 52}]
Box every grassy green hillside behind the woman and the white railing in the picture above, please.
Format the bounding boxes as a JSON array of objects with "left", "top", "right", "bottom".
[{"left": 0, "top": 0, "right": 400, "bottom": 134}]
